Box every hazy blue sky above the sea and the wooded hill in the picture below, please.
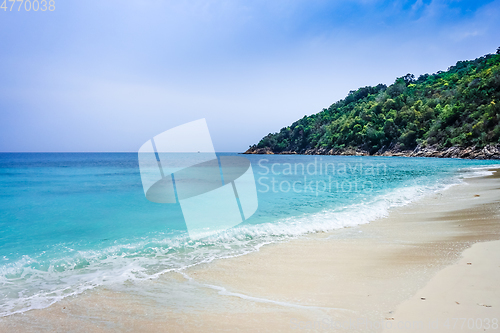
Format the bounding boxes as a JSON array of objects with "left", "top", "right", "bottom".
[{"left": 0, "top": 0, "right": 500, "bottom": 152}]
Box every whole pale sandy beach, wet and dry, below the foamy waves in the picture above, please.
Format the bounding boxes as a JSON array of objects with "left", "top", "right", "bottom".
[{"left": 0, "top": 172, "right": 500, "bottom": 332}]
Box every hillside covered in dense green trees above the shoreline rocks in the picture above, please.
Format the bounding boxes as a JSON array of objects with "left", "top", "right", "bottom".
[{"left": 247, "top": 48, "right": 500, "bottom": 158}]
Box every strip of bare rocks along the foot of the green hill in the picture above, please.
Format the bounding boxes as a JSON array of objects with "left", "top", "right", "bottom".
[{"left": 243, "top": 144, "right": 500, "bottom": 160}]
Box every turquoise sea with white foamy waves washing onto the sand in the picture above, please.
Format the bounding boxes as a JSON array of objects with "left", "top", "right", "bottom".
[{"left": 0, "top": 153, "right": 499, "bottom": 316}]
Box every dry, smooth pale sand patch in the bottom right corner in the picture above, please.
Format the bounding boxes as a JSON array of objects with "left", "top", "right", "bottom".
[{"left": 384, "top": 241, "right": 500, "bottom": 332}]
